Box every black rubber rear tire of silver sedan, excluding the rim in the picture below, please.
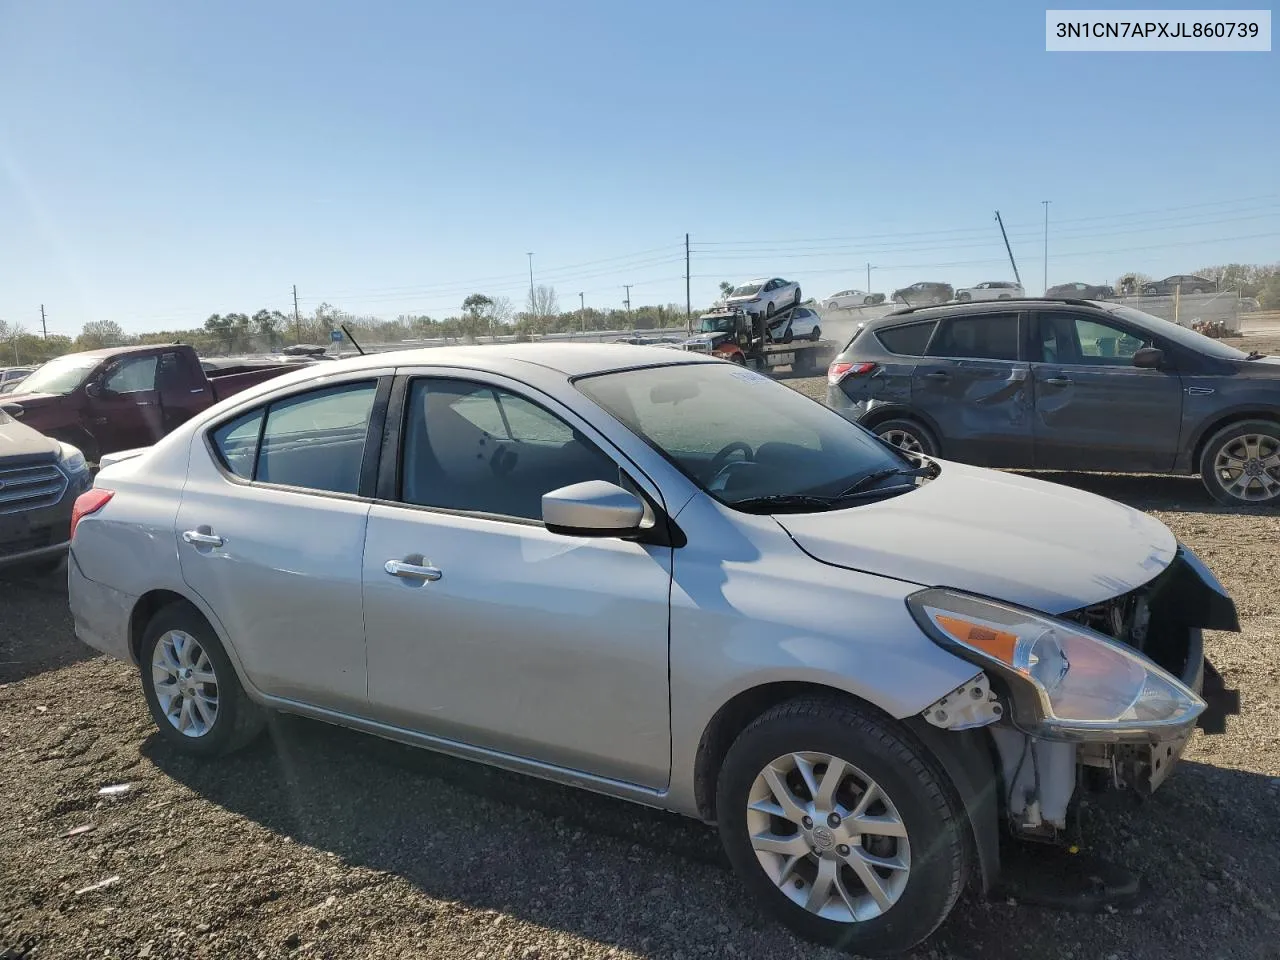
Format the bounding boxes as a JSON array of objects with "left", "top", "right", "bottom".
[{"left": 138, "top": 603, "right": 266, "bottom": 756}]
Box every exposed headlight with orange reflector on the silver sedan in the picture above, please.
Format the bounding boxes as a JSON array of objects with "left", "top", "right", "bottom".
[{"left": 906, "top": 588, "right": 1206, "bottom": 741}]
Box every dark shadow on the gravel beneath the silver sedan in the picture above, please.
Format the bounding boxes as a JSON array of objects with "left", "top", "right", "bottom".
[{"left": 143, "top": 717, "right": 1280, "bottom": 960}]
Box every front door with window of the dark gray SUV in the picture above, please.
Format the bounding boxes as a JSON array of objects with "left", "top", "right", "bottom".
[{"left": 1032, "top": 312, "right": 1183, "bottom": 471}]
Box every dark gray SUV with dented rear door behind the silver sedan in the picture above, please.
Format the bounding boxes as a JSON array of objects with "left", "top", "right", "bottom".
[{"left": 827, "top": 300, "right": 1280, "bottom": 506}]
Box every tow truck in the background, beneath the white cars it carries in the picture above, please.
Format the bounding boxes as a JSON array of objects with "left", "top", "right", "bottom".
[{"left": 676, "top": 303, "right": 838, "bottom": 376}]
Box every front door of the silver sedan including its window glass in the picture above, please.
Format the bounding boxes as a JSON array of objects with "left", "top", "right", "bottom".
[{"left": 364, "top": 378, "right": 672, "bottom": 787}]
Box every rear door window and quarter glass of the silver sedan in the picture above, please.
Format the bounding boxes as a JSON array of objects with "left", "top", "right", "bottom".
[{"left": 210, "top": 381, "right": 376, "bottom": 494}]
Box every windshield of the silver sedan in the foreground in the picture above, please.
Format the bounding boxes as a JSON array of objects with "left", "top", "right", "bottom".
[{"left": 577, "top": 364, "right": 910, "bottom": 509}]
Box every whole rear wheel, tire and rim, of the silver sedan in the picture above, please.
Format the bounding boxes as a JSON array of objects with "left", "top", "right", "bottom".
[{"left": 138, "top": 603, "right": 265, "bottom": 756}]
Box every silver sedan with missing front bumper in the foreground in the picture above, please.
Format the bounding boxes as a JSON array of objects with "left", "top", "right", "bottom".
[{"left": 68, "top": 344, "right": 1234, "bottom": 952}]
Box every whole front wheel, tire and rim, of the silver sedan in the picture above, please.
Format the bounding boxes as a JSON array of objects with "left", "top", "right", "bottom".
[{"left": 716, "top": 699, "right": 966, "bottom": 954}]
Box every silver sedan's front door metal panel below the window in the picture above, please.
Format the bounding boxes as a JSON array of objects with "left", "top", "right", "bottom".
[{"left": 364, "top": 504, "right": 671, "bottom": 787}]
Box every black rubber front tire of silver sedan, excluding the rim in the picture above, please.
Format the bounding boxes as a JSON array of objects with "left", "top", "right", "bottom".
[{"left": 716, "top": 698, "right": 969, "bottom": 955}]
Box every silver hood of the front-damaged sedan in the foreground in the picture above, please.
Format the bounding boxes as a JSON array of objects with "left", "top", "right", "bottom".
[{"left": 774, "top": 461, "right": 1178, "bottom": 616}]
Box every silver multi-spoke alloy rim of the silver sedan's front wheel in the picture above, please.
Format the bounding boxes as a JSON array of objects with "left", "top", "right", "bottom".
[{"left": 746, "top": 753, "right": 911, "bottom": 923}]
